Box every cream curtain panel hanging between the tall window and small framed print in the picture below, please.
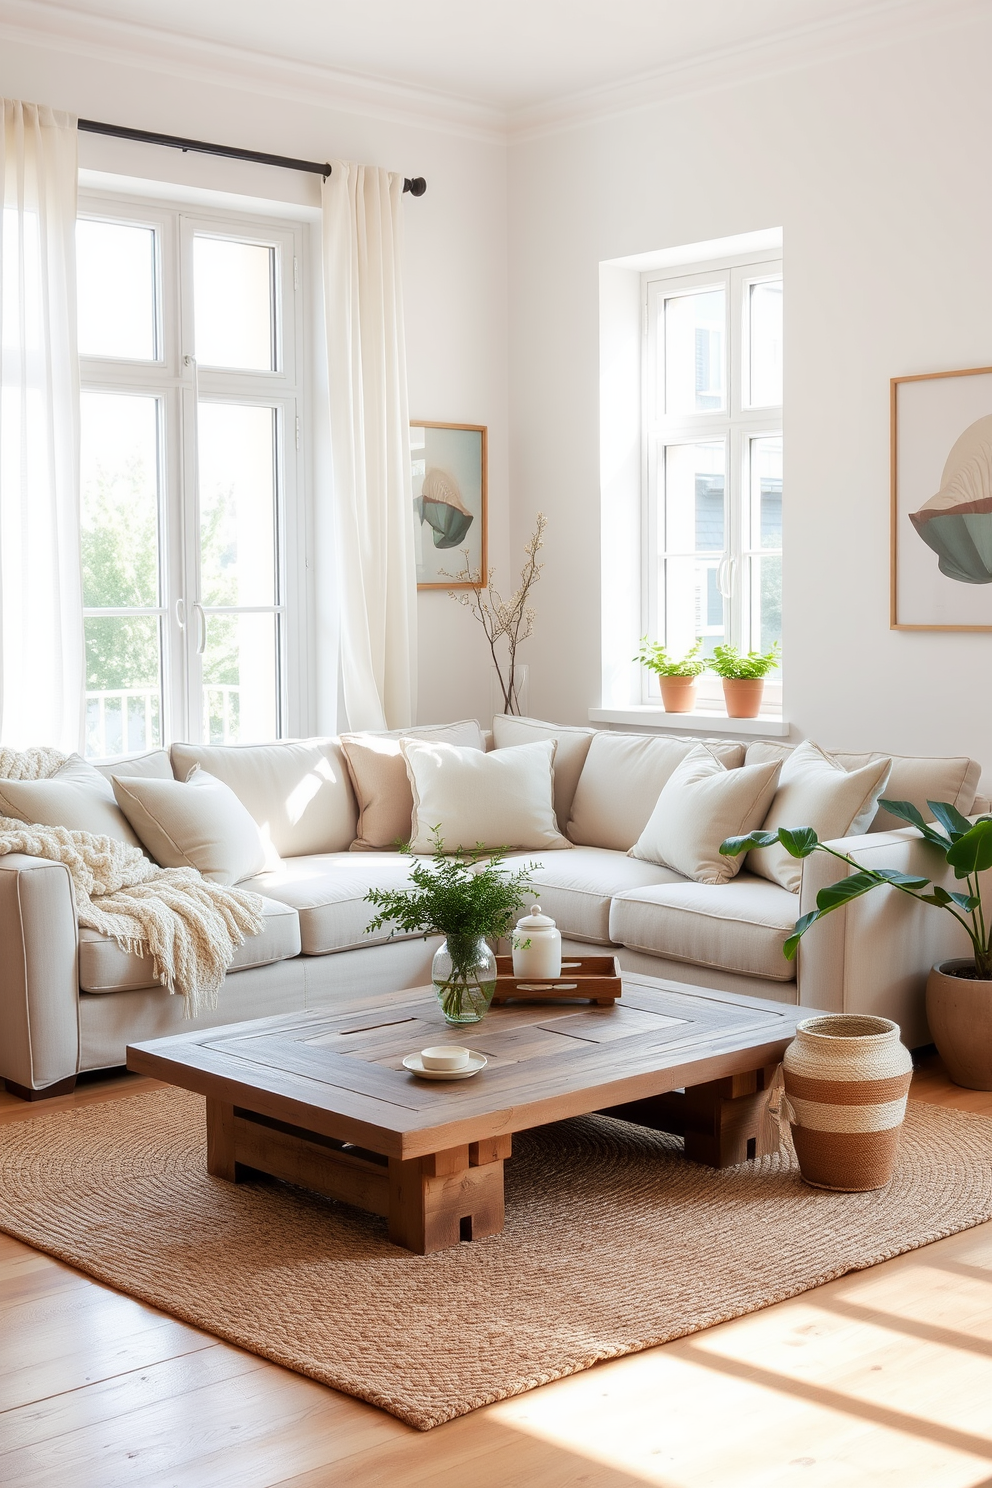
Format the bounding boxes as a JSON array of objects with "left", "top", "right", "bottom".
[{"left": 323, "top": 161, "right": 416, "bottom": 729}]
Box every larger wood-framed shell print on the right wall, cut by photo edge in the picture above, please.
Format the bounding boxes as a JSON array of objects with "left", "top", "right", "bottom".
[{"left": 889, "top": 368, "right": 992, "bottom": 631}]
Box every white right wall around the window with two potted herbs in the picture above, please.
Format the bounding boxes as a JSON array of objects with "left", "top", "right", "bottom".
[{"left": 510, "top": 12, "right": 992, "bottom": 769}]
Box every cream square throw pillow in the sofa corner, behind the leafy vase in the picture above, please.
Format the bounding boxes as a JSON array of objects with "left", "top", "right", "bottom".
[{"left": 400, "top": 740, "right": 571, "bottom": 853}]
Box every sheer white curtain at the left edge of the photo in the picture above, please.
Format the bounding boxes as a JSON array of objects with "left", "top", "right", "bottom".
[{"left": 0, "top": 98, "right": 85, "bottom": 750}]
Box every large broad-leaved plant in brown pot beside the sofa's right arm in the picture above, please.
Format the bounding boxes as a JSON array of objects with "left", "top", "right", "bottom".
[{"left": 720, "top": 801, "right": 992, "bottom": 1091}]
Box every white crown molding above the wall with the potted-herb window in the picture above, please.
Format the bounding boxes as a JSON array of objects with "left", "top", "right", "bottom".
[{"left": 507, "top": 0, "right": 992, "bottom": 144}]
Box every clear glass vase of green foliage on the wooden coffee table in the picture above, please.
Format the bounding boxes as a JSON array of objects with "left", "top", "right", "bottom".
[{"left": 366, "top": 827, "right": 537, "bottom": 1027}]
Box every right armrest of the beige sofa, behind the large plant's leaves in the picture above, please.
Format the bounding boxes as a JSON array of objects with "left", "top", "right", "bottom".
[{"left": 799, "top": 827, "right": 970, "bottom": 1049}]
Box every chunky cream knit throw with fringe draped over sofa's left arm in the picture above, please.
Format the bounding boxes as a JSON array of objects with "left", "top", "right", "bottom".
[{"left": 0, "top": 748, "right": 265, "bottom": 1018}]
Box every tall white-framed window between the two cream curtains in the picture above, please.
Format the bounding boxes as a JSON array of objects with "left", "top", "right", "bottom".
[{"left": 77, "top": 199, "right": 302, "bottom": 756}]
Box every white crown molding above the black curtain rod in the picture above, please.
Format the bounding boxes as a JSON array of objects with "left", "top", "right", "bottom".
[{"left": 0, "top": 0, "right": 507, "bottom": 144}]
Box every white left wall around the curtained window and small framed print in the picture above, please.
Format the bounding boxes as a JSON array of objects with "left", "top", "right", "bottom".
[{"left": 0, "top": 40, "right": 509, "bottom": 722}]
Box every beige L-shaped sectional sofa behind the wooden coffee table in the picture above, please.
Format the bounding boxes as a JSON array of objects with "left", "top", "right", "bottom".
[{"left": 0, "top": 719, "right": 988, "bottom": 1098}]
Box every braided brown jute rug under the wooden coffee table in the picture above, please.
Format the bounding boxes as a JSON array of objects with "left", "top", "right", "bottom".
[{"left": 0, "top": 1089, "right": 992, "bottom": 1430}]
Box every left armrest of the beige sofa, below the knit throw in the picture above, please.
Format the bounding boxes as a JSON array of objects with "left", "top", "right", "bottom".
[{"left": 0, "top": 853, "right": 79, "bottom": 1091}]
